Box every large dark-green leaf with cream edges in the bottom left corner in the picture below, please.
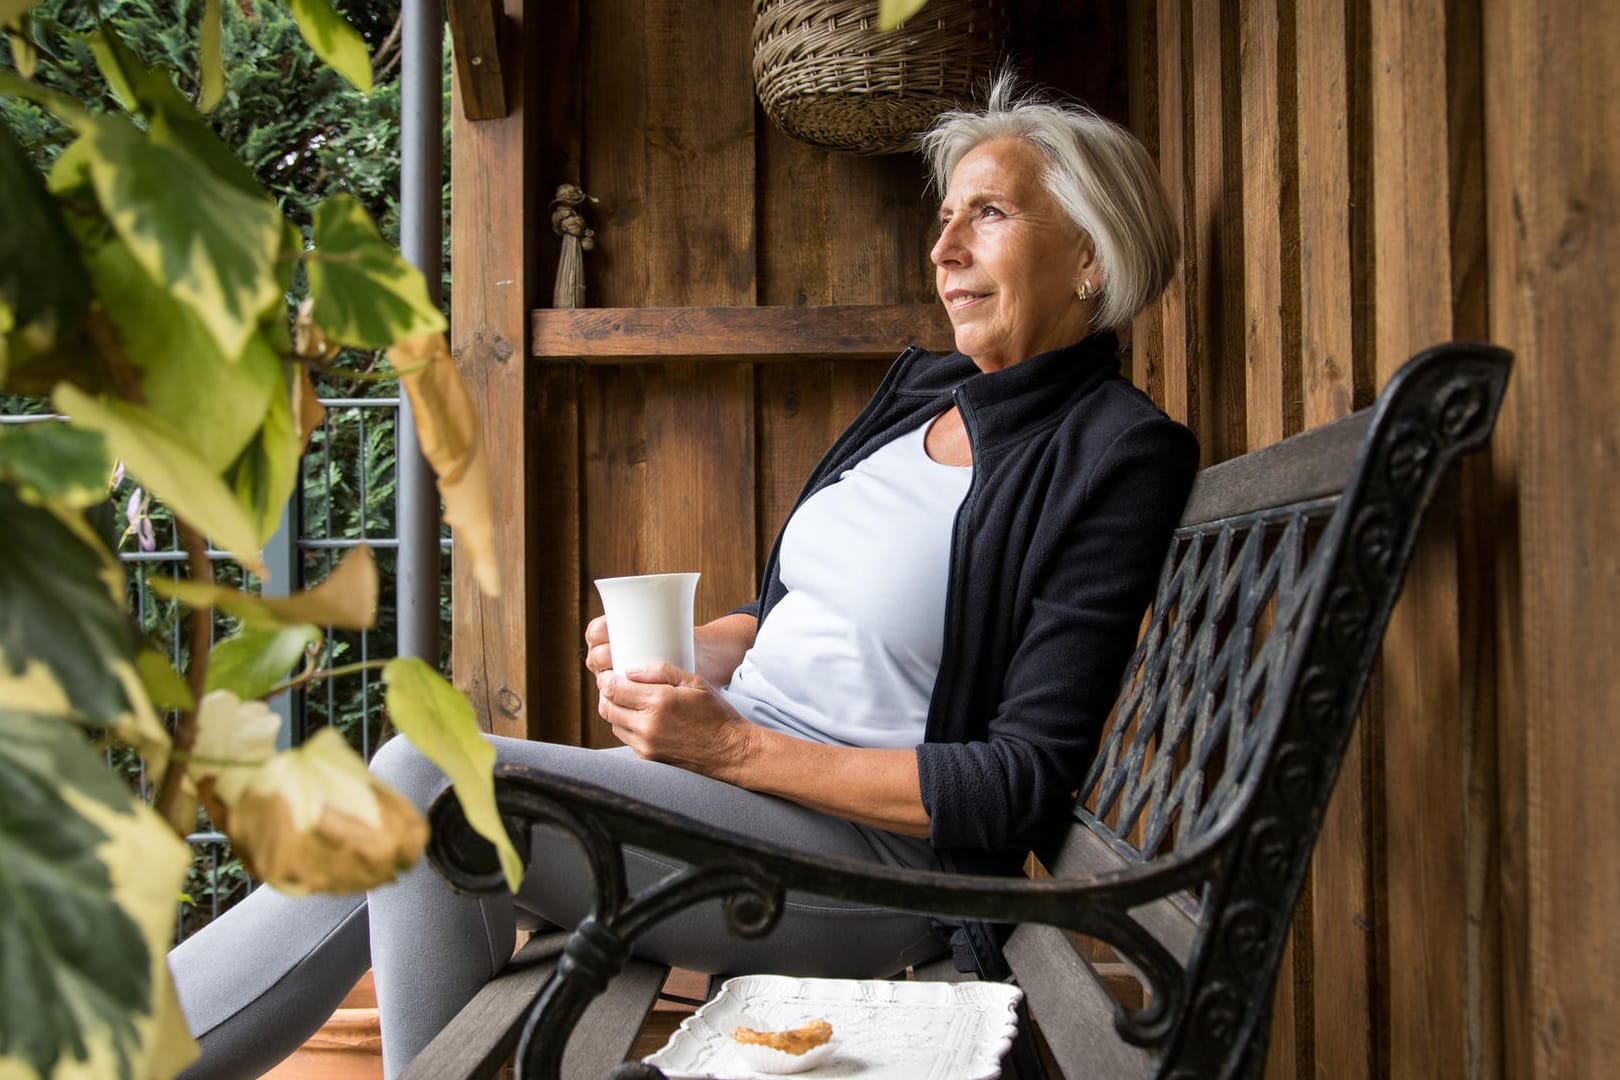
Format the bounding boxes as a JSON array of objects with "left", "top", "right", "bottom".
[{"left": 0, "top": 708, "right": 190, "bottom": 1078}]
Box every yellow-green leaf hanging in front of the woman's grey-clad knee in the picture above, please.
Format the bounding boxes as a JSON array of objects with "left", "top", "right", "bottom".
[{"left": 382, "top": 656, "right": 523, "bottom": 892}]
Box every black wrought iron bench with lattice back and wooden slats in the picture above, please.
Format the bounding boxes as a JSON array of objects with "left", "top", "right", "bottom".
[{"left": 407, "top": 345, "right": 1511, "bottom": 1080}]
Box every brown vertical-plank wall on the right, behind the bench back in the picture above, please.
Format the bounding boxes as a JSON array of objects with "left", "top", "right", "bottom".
[{"left": 1129, "top": 0, "right": 1620, "bottom": 1080}]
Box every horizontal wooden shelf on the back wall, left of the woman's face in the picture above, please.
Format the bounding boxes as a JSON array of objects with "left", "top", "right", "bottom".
[{"left": 531, "top": 304, "right": 954, "bottom": 364}]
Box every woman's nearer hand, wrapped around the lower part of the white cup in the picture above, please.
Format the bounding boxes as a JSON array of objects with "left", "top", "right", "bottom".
[{"left": 586, "top": 663, "right": 758, "bottom": 782}]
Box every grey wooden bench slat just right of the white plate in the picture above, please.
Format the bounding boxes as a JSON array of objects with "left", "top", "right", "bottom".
[{"left": 1006, "top": 925, "right": 1152, "bottom": 1080}]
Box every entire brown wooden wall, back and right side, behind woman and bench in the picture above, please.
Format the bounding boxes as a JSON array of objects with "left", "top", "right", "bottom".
[{"left": 452, "top": 0, "right": 1620, "bottom": 1080}]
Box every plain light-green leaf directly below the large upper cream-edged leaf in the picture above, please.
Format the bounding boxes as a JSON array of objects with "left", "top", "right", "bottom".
[{"left": 89, "top": 240, "right": 285, "bottom": 469}]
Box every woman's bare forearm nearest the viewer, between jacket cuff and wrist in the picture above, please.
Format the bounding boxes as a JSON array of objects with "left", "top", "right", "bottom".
[{"left": 721, "top": 725, "right": 928, "bottom": 837}]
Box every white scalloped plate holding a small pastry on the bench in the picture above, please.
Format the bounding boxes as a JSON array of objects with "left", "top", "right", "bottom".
[{"left": 643, "top": 975, "right": 1024, "bottom": 1080}]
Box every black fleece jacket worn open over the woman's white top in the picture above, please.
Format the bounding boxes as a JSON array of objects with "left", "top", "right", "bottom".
[{"left": 739, "top": 334, "right": 1199, "bottom": 873}]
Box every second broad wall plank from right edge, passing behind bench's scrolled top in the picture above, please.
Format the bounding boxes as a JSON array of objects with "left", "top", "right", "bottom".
[{"left": 1371, "top": 0, "right": 1469, "bottom": 1077}]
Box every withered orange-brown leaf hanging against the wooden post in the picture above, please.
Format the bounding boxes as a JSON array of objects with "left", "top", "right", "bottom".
[{"left": 389, "top": 334, "right": 501, "bottom": 596}]
